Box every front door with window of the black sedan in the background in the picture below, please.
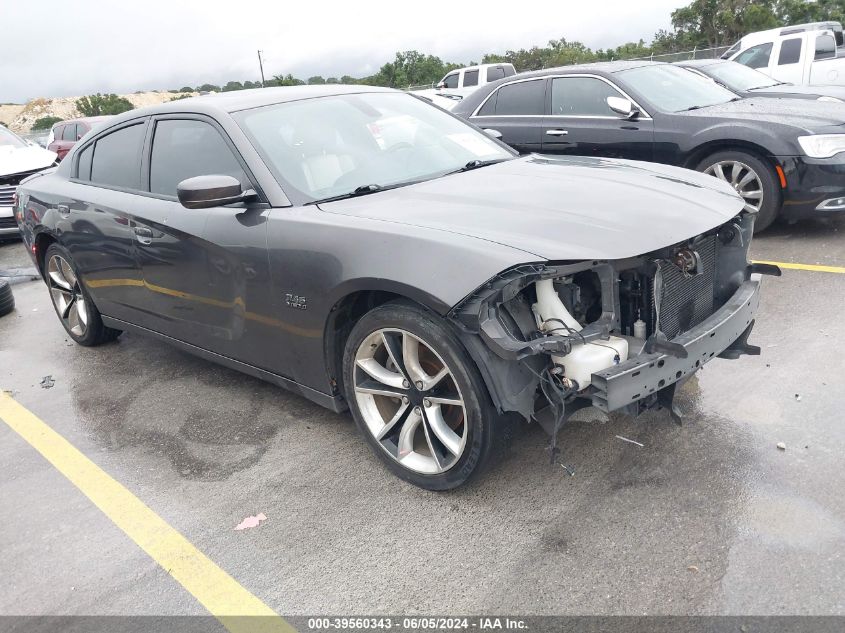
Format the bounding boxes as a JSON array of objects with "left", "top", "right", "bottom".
[{"left": 542, "top": 74, "right": 654, "bottom": 161}]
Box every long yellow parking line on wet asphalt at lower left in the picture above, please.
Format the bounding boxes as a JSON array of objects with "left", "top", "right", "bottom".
[{"left": 0, "top": 392, "right": 295, "bottom": 633}]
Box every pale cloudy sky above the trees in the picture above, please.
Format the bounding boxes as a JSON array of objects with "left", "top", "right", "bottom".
[{"left": 0, "top": 0, "right": 689, "bottom": 103}]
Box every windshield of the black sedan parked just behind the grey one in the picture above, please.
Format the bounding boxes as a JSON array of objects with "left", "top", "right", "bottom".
[{"left": 617, "top": 64, "right": 738, "bottom": 112}]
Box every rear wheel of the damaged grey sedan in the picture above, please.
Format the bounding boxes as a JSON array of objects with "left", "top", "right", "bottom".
[{"left": 44, "top": 243, "right": 121, "bottom": 347}]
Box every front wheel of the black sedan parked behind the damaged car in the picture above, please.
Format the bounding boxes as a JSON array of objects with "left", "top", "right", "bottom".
[{"left": 698, "top": 150, "right": 781, "bottom": 233}]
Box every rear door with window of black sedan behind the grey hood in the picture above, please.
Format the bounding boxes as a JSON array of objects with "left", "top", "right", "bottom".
[{"left": 470, "top": 77, "right": 548, "bottom": 154}]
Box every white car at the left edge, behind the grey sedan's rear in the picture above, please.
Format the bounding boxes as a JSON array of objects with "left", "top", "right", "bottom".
[{"left": 0, "top": 125, "right": 56, "bottom": 238}]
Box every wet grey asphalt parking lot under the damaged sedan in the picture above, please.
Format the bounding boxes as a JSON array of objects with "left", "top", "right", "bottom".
[{"left": 0, "top": 219, "right": 845, "bottom": 615}]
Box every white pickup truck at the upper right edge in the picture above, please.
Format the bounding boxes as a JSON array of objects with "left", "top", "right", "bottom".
[{"left": 722, "top": 22, "right": 845, "bottom": 86}]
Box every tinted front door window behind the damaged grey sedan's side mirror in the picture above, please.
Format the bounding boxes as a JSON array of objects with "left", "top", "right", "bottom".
[{"left": 150, "top": 119, "right": 250, "bottom": 197}]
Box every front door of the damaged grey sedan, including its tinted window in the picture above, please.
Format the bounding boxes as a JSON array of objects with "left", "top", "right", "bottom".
[{"left": 136, "top": 115, "right": 269, "bottom": 366}]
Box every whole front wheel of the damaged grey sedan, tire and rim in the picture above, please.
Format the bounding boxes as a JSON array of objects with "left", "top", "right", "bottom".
[{"left": 343, "top": 301, "right": 495, "bottom": 490}]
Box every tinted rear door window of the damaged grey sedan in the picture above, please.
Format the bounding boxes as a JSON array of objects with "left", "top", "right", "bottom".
[{"left": 91, "top": 122, "right": 146, "bottom": 189}]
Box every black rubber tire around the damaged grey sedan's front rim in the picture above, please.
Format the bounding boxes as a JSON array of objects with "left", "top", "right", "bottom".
[{"left": 343, "top": 301, "right": 496, "bottom": 490}]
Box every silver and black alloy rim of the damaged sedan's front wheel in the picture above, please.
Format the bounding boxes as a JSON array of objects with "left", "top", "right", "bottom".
[{"left": 353, "top": 328, "right": 468, "bottom": 475}]
